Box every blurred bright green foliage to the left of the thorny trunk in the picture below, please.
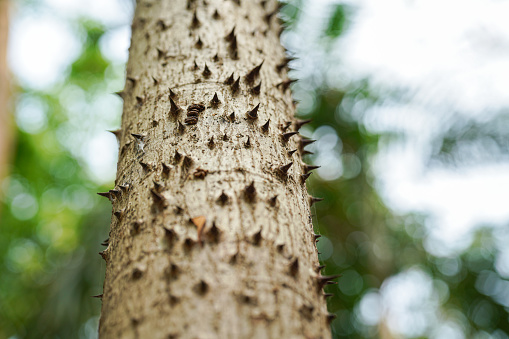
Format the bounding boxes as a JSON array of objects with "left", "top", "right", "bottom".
[{"left": 0, "top": 21, "right": 119, "bottom": 338}]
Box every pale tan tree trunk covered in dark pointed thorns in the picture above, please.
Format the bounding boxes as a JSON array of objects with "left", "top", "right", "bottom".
[{"left": 99, "top": 0, "right": 333, "bottom": 338}]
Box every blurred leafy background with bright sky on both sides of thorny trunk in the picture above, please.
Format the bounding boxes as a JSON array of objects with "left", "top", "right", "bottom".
[{"left": 0, "top": 0, "right": 509, "bottom": 339}]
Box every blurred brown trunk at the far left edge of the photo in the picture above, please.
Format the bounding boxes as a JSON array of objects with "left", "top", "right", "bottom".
[{"left": 0, "top": 0, "right": 12, "bottom": 205}]
